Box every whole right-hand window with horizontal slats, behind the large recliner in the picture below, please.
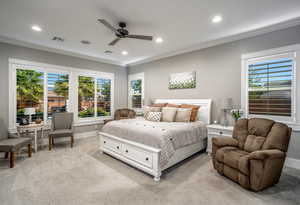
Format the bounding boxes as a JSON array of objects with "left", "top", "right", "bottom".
[{"left": 241, "top": 45, "right": 300, "bottom": 130}]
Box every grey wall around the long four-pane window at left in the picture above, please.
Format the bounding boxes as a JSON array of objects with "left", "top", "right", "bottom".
[{"left": 0, "top": 43, "right": 127, "bottom": 132}]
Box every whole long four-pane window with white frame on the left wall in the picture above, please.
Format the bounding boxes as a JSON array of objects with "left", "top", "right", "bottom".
[{"left": 9, "top": 59, "right": 114, "bottom": 131}]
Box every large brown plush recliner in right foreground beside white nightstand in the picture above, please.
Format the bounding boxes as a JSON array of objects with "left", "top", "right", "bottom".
[{"left": 212, "top": 118, "right": 292, "bottom": 191}]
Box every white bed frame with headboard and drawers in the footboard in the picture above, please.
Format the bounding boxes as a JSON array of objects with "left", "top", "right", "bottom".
[{"left": 99, "top": 99, "right": 212, "bottom": 181}]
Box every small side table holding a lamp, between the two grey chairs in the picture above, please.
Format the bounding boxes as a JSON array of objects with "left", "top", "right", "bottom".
[{"left": 17, "top": 123, "right": 44, "bottom": 152}]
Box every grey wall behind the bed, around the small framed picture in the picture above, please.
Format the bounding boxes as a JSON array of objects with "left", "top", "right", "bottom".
[{"left": 129, "top": 26, "right": 300, "bottom": 159}]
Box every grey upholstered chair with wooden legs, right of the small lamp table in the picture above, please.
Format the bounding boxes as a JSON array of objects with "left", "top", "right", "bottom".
[{"left": 49, "top": 112, "right": 74, "bottom": 150}]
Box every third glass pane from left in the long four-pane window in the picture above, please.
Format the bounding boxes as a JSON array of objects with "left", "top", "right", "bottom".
[{"left": 78, "top": 76, "right": 95, "bottom": 118}]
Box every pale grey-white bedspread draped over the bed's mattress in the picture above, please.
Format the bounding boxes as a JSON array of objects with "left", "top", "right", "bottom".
[{"left": 102, "top": 119, "right": 207, "bottom": 167}]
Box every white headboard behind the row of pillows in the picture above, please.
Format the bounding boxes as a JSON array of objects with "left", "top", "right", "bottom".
[{"left": 154, "top": 99, "right": 212, "bottom": 124}]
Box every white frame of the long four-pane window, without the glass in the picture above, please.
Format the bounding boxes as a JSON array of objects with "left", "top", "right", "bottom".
[{"left": 8, "top": 58, "right": 115, "bottom": 130}]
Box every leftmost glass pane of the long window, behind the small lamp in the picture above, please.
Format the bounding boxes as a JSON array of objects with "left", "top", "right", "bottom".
[{"left": 16, "top": 69, "right": 44, "bottom": 123}]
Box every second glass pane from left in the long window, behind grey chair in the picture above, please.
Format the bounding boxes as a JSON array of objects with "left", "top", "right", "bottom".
[{"left": 47, "top": 73, "right": 69, "bottom": 118}]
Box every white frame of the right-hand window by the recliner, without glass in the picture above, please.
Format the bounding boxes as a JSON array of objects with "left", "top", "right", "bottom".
[{"left": 241, "top": 44, "right": 300, "bottom": 130}]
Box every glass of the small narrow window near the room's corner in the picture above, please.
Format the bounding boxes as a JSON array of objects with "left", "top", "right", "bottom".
[{"left": 130, "top": 79, "right": 142, "bottom": 108}]
